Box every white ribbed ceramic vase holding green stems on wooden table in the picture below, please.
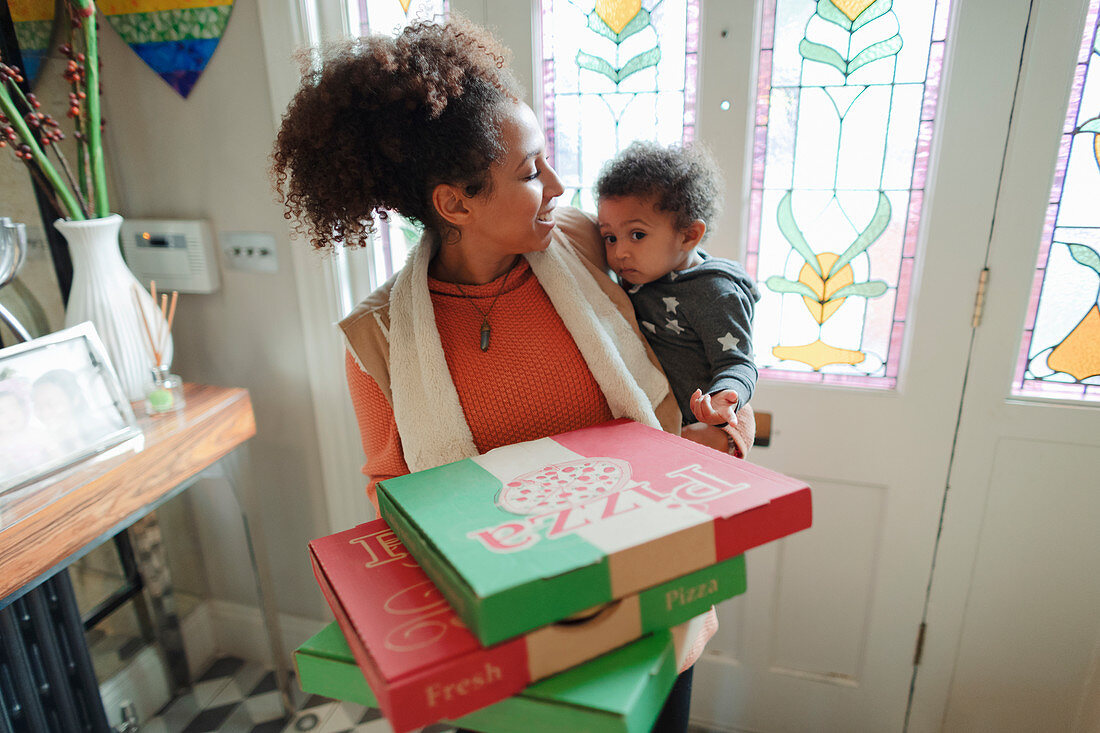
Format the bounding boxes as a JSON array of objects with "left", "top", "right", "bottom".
[{"left": 54, "top": 214, "right": 172, "bottom": 402}]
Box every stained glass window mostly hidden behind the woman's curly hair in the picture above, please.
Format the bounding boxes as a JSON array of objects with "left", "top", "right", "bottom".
[{"left": 352, "top": 0, "right": 448, "bottom": 279}]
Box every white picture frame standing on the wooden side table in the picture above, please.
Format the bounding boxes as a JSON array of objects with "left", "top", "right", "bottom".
[{"left": 0, "top": 322, "right": 143, "bottom": 495}]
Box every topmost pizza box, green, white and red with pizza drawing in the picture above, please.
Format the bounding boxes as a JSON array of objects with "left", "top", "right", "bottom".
[{"left": 378, "top": 419, "right": 812, "bottom": 645}]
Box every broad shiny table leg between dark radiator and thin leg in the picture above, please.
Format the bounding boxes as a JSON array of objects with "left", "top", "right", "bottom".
[{"left": 128, "top": 512, "right": 191, "bottom": 693}]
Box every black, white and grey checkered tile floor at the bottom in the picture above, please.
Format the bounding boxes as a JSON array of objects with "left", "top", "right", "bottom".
[{"left": 141, "top": 657, "right": 454, "bottom": 733}]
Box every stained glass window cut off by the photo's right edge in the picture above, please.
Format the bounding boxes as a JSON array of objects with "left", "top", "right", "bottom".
[{"left": 1013, "top": 0, "right": 1100, "bottom": 401}]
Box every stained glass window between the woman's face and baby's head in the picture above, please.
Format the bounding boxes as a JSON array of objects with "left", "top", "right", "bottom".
[{"left": 541, "top": 0, "right": 699, "bottom": 210}]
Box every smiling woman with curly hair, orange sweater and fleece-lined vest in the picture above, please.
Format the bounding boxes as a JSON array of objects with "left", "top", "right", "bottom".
[{"left": 273, "top": 19, "right": 751, "bottom": 730}]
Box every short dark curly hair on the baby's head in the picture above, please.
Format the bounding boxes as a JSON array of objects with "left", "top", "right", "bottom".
[{"left": 595, "top": 141, "right": 722, "bottom": 238}]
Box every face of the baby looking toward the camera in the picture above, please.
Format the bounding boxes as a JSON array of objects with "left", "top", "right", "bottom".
[{"left": 598, "top": 196, "right": 695, "bottom": 285}]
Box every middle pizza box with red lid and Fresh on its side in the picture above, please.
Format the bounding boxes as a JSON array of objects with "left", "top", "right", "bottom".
[{"left": 309, "top": 519, "right": 746, "bottom": 730}]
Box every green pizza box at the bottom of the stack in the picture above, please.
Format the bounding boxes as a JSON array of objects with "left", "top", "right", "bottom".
[{"left": 294, "top": 623, "right": 677, "bottom": 733}]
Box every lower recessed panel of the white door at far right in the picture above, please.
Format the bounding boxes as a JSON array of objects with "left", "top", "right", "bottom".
[{"left": 943, "top": 437, "right": 1100, "bottom": 731}]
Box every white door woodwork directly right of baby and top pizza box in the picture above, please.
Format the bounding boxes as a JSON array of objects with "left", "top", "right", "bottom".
[{"left": 692, "top": 0, "right": 1029, "bottom": 732}]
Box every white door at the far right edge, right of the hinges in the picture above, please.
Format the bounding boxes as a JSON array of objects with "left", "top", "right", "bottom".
[{"left": 911, "top": 0, "right": 1100, "bottom": 733}]
